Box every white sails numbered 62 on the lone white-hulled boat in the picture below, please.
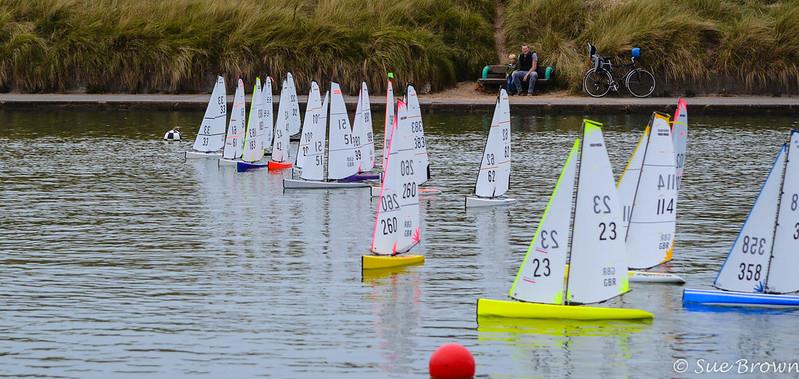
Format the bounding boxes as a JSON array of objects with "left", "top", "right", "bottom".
[{"left": 474, "top": 89, "right": 511, "bottom": 197}]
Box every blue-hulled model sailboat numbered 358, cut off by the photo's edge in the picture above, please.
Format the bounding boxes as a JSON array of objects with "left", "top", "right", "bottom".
[{"left": 683, "top": 130, "right": 799, "bottom": 306}]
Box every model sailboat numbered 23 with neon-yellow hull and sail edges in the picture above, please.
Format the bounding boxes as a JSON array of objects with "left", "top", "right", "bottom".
[{"left": 477, "top": 120, "right": 653, "bottom": 320}]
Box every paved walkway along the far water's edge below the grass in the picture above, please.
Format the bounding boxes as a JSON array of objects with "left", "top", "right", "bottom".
[{"left": 0, "top": 94, "right": 799, "bottom": 116}]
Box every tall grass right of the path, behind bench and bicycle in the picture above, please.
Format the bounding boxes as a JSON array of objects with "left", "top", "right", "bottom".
[{"left": 504, "top": 0, "right": 799, "bottom": 94}]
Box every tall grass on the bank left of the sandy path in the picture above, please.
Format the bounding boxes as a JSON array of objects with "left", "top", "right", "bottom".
[{"left": 0, "top": 0, "right": 494, "bottom": 93}]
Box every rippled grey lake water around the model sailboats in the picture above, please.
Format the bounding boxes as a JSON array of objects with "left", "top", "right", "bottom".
[{"left": 0, "top": 105, "right": 799, "bottom": 378}]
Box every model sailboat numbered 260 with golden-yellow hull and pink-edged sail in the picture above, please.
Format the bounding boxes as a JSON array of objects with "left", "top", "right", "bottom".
[{"left": 361, "top": 101, "right": 424, "bottom": 270}]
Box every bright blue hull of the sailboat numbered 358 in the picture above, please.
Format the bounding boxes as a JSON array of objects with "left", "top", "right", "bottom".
[{"left": 682, "top": 288, "right": 799, "bottom": 307}]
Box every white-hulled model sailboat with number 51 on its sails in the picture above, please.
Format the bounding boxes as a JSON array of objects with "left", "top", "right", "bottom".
[{"left": 283, "top": 82, "right": 370, "bottom": 189}]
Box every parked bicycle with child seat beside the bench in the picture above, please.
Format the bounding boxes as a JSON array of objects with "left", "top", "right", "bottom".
[{"left": 583, "top": 42, "right": 655, "bottom": 97}]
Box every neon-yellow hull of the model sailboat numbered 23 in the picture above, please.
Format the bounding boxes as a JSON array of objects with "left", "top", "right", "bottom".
[{"left": 477, "top": 299, "right": 655, "bottom": 320}]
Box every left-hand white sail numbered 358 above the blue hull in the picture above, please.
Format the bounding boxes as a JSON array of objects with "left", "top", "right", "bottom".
[{"left": 713, "top": 146, "right": 787, "bottom": 293}]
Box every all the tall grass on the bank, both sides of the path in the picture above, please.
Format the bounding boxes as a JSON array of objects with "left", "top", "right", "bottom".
[{"left": 0, "top": 0, "right": 799, "bottom": 95}]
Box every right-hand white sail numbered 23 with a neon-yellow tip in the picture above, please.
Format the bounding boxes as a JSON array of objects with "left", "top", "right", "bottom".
[{"left": 566, "top": 120, "right": 629, "bottom": 304}]
